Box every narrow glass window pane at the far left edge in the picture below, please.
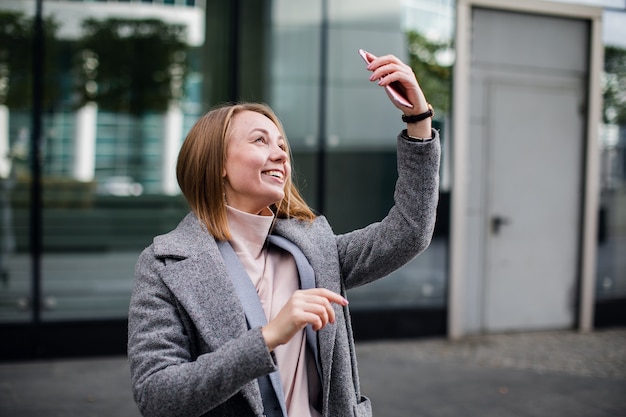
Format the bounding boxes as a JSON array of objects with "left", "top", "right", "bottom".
[{"left": 0, "top": 2, "right": 34, "bottom": 324}]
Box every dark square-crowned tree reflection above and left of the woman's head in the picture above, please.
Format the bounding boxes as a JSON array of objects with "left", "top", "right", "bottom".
[{"left": 77, "top": 19, "right": 187, "bottom": 116}]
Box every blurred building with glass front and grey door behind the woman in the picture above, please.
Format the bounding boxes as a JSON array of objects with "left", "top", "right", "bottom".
[{"left": 0, "top": 0, "right": 626, "bottom": 359}]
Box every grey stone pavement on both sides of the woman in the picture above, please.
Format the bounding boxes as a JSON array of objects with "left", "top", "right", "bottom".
[{"left": 0, "top": 328, "right": 626, "bottom": 417}]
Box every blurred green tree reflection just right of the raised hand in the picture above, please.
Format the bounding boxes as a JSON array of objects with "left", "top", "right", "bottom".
[{"left": 407, "top": 31, "right": 452, "bottom": 112}]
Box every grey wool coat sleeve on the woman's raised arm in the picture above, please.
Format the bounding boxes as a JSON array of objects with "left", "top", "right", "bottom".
[{"left": 337, "top": 130, "right": 441, "bottom": 288}]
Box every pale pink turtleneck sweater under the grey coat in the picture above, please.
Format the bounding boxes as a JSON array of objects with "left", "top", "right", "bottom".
[{"left": 226, "top": 206, "right": 320, "bottom": 417}]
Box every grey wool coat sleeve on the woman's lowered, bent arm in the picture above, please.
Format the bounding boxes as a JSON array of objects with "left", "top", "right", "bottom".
[{"left": 128, "top": 247, "right": 276, "bottom": 416}]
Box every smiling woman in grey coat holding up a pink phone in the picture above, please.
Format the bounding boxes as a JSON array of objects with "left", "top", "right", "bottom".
[{"left": 128, "top": 55, "right": 439, "bottom": 417}]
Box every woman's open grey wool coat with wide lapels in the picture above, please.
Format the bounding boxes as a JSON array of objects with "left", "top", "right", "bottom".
[{"left": 128, "top": 131, "right": 440, "bottom": 417}]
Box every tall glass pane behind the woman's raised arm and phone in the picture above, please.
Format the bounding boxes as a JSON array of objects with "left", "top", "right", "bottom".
[{"left": 327, "top": 1, "right": 453, "bottom": 311}]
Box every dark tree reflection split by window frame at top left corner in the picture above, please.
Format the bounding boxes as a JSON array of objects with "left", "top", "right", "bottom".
[{"left": 0, "top": 11, "right": 59, "bottom": 110}]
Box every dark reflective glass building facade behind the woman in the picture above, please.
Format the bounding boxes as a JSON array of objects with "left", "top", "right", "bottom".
[{"left": 0, "top": 0, "right": 626, "bottom": 358}]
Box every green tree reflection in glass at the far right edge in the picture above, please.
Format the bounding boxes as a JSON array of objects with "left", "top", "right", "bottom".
[{"left": 603, "top": 46, "right": 626, "bottom": 125}]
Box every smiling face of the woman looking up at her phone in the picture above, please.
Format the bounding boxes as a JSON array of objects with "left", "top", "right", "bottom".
[{"left": 224, "top": 110, "right": 291, "bottom": 214}]
